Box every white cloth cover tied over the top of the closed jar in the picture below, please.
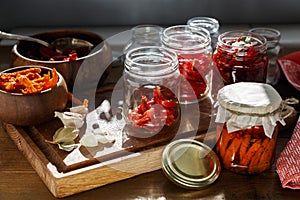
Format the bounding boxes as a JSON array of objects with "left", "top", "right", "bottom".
[{"left": 216, "top": 82, "right": 285, "bottom": 138}]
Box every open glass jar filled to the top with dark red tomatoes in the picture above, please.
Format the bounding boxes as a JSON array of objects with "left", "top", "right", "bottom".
[{"left": 213, "top": 31, "right": 268, "bottom": 85}]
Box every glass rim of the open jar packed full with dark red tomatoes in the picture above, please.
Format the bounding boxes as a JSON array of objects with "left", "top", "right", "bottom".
[{"left": 218, "top": 30, "right": 267, "bottom": 50}]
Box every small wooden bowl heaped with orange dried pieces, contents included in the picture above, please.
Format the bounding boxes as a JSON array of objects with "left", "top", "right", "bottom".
[{"left": 0, "top": 66, "right": 68, "bottom": 126}]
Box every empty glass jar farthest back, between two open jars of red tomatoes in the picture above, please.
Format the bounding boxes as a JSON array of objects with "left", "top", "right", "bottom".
[{"left": 187, "top": 17, "right": 220, "bottom": 50}]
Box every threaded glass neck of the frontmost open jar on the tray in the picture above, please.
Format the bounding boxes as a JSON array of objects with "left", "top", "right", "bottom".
[{"left": 124, "top": 46, "right": 178, "bottom": 77}]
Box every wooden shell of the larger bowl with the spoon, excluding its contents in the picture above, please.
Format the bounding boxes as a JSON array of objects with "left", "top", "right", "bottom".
[{"left": 10, "top": 30, "right": 112, "bottom": 91}]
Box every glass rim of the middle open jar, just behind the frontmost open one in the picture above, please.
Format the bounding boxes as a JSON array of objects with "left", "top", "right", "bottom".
[{"left": 162, "top": 25, "right": 211, "bottom": 51}]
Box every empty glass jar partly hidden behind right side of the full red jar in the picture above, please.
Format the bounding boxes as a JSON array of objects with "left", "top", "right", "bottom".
[{"left": 249, "top": 27, "right": 281, "bottom": 85}]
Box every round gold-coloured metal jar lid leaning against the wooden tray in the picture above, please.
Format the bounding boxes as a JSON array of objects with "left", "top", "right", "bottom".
[{"left": 162, "top": 139, "right": 221, "bottom": 189}]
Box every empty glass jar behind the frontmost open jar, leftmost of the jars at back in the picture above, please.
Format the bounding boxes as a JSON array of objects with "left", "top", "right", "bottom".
[{"left": 123, "top": 24, "right": 163, "bottom": 54}]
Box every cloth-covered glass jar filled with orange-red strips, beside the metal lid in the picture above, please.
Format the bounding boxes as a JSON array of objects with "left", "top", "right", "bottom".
[{"left": 216, "top": 82, "right": 285, "bottom": 174}]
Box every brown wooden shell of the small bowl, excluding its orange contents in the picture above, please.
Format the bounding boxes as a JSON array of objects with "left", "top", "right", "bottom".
[{"left": 0, "top": 66, "right": 68, "bottom": 126}]
